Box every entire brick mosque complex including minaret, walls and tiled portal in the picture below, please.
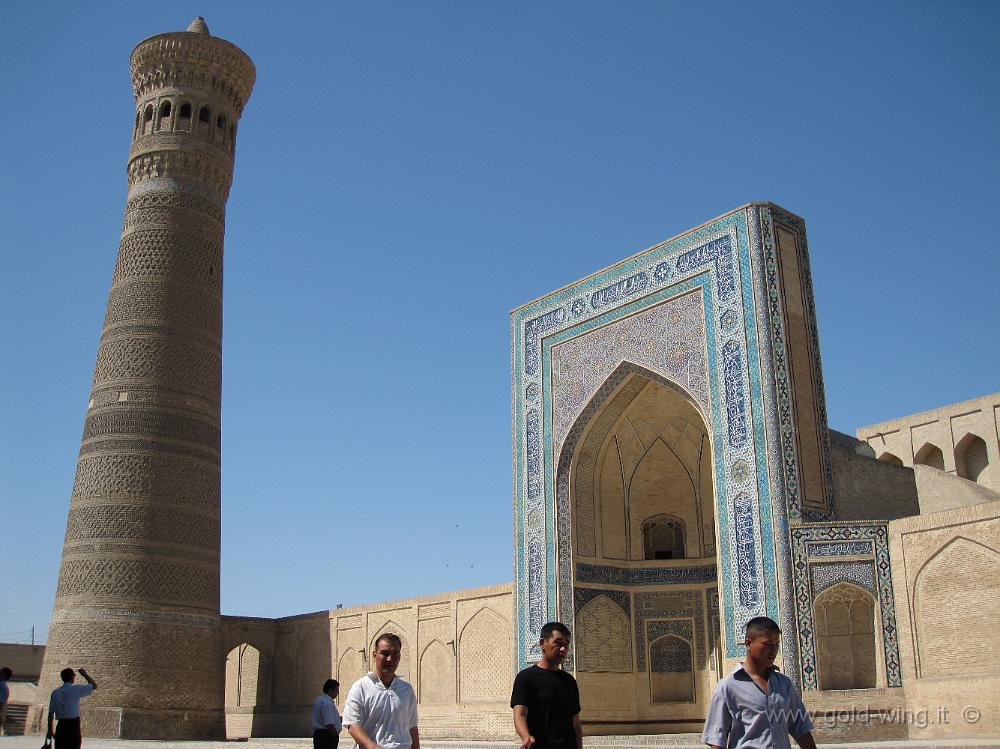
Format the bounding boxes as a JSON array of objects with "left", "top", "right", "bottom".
[{"left": 29, "top": 21, "right": 1000, "bottom": 740}]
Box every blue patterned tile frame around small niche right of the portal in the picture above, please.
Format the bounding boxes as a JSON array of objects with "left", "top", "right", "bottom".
[{"left": 791, "top": 522, "right": 903, "bottom": 689}]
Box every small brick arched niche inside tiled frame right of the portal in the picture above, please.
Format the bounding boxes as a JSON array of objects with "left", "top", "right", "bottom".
[{"left": 813, "top": 582, "right": 878, "bottom": 689}]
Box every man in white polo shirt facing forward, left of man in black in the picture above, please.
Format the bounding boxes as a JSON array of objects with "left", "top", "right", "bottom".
[{"left": 344, "top": 632, "right": 420, "bottom": 749}]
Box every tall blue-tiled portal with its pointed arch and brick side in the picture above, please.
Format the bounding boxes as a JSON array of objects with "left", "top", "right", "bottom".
[{"left": 512, "top": 204, "right": 832, "bottom": 719}]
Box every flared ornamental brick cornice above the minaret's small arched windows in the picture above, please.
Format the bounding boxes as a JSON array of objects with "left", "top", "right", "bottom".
[{"left": 130, "top": 31, "right": 257, "bottom": 115}]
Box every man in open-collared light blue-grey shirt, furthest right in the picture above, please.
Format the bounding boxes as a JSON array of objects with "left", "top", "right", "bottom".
[{"left": 701, "top": 616, "right": 816, "bottom": 749}]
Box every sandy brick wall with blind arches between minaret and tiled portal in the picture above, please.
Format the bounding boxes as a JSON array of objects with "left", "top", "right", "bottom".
[{"left": 223, "top": 583, "right": 514, "bottom": 739}]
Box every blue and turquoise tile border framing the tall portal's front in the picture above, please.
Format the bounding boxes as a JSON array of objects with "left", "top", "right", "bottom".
[{"left": 511, "top": 204, "right": 831, "bottom": 678}]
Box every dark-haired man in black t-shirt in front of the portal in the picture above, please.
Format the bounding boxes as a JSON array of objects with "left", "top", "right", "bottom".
[{"left": 510, "top": 622, "right": 583, "bottom": 749}]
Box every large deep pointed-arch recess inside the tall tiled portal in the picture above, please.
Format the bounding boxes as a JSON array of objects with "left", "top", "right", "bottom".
[{"left": 556, "top": 362, "right": 717, "bottom": 720}]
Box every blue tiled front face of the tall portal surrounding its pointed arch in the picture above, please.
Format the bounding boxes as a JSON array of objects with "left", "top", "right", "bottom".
[{"left": 511, "top": 205, "right": 828, "bottom": 664}]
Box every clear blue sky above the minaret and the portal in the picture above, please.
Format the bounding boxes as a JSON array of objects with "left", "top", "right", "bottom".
[{"left": 0, "top": 0, "right": 1000, "bottom": 641}]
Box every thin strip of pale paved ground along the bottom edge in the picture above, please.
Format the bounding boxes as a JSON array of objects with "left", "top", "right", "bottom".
[{"left": 0, "top": 734, "right": 1000, "bottom": 749}]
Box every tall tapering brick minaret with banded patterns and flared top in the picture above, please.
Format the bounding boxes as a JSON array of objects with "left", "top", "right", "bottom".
[{"left": 30, "top": 18, "right": 255, "bottom": 739}]
